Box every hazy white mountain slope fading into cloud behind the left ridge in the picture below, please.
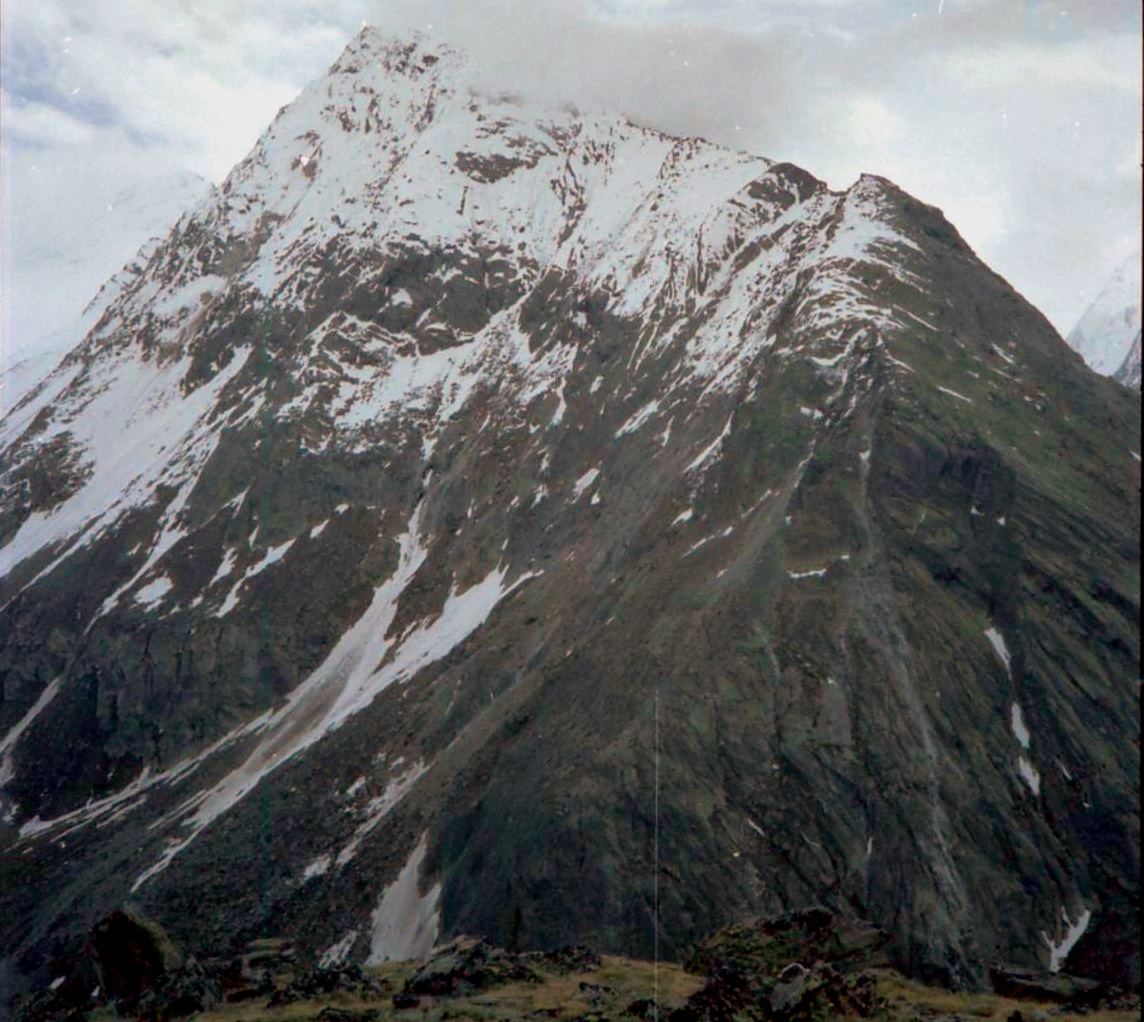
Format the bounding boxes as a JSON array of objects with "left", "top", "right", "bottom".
[{"left": 0, "top": 160, "right": 210, "bottom": 411}]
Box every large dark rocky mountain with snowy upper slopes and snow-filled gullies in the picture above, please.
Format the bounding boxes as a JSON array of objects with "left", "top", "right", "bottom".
[{"left": 0, "top": 30, "right": 1139, "bottom": 1002}]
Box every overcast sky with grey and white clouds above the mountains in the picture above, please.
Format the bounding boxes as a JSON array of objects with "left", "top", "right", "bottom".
[{"left": 2, "top": 0, "right": 1142, "bottom": 350}]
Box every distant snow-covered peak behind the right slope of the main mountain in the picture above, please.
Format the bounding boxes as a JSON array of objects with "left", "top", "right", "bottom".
[{"left": 1068, "top": 252, "right": 1141, "bottom": 390}]
